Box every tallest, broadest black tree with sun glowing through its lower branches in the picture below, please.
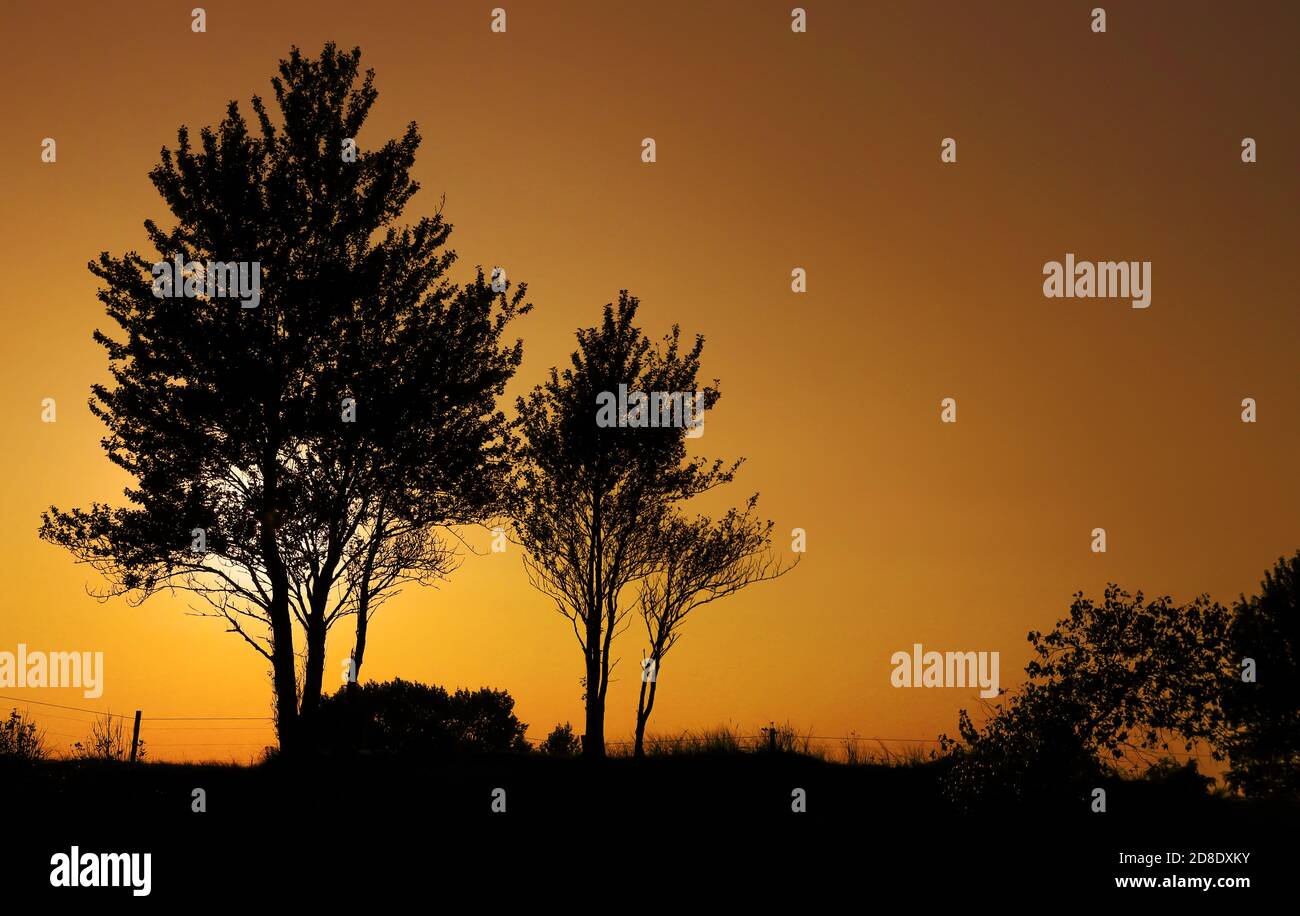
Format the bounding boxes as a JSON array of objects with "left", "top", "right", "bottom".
[{"left": 40, "top": 44, "right": 528, "bottom": 751}]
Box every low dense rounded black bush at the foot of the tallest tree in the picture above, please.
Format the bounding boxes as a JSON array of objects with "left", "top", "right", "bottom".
[{"left": 320, "top": 678, "right": 529, "bottom": 756}]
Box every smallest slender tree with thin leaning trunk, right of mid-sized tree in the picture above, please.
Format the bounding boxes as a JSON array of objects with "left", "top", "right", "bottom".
[{"left": 633, "top": 504, "right": 798, "bottom": 757}]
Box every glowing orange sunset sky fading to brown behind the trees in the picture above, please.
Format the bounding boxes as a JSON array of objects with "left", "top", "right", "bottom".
[{"left": 0, "top": 0, "right": 1300, "bottom": 760}]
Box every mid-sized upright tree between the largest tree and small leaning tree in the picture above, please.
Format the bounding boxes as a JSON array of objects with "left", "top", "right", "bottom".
[{"left": 511, "top": 291, "right": 740, "bottom": 756}]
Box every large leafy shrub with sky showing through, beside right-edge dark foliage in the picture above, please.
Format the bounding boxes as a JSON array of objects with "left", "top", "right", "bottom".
[{"left": 941, "top": 585, "right": 1230, "bottom": 808}]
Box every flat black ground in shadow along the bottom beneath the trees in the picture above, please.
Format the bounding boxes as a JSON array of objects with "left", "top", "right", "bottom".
[{"left": 3, "top": 754, "right": 1300, "bottom": 902}]
